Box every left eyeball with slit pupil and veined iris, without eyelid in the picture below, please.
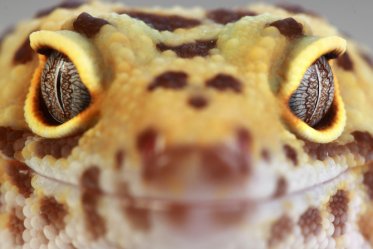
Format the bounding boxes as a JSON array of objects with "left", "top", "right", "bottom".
[{"left": 40, "top": 52, "right": 91, "bottom": 124}]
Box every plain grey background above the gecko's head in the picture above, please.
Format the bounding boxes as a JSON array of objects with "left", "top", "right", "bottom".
[{"left": 0, "top": 0, "right": 373, "bottom": 50}]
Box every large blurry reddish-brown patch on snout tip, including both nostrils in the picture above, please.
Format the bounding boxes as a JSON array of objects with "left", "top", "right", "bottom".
[{"left": 138, "top": 128, "right": 251, "bottom": 185}]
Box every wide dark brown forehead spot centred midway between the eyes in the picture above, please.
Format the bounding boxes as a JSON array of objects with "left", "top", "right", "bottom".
[{"left": 157, "top": 40, "right": 217, "bottom": 58}]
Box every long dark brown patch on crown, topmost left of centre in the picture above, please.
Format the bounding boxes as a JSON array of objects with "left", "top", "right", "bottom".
[{"left": 123, "top": 11, "right": 201, "bottom": 31}]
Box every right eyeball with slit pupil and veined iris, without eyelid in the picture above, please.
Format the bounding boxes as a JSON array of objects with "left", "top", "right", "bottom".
[{"left": 289, "top": 56, "right": 334, "bottom": 127}]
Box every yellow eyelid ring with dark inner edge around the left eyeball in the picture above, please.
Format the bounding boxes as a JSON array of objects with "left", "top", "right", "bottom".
[{"left": 25, "top": 31, "right": 103, "bottom": 138}]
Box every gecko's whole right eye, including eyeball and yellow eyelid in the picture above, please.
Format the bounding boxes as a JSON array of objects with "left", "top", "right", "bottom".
[{"left": 278, "top": 36, "right": 346, "bottom": 143}]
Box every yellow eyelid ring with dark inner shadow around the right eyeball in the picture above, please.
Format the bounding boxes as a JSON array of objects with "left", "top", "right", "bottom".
[{"left": 278, "top": 36, "right": 346, "bottom": 143}]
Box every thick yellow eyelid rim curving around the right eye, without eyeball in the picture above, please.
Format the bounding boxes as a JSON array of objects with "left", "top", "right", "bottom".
[{"left": 278, "top": 36, "right": 346, "bottom": 143}]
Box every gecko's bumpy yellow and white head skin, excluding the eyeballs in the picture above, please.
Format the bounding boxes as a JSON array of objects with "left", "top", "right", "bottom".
[{"left": 0, "top": 2, "right": 373, "bottom": 249}]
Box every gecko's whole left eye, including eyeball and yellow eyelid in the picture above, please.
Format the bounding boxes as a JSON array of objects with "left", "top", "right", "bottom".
[{"left": 25, "top": 30, "right": 101, "bottom": 138}]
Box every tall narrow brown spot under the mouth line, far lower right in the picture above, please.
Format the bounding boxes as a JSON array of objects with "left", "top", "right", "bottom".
[{"left": 329, "top": 190, "right": 350, "bottom": 237}]
